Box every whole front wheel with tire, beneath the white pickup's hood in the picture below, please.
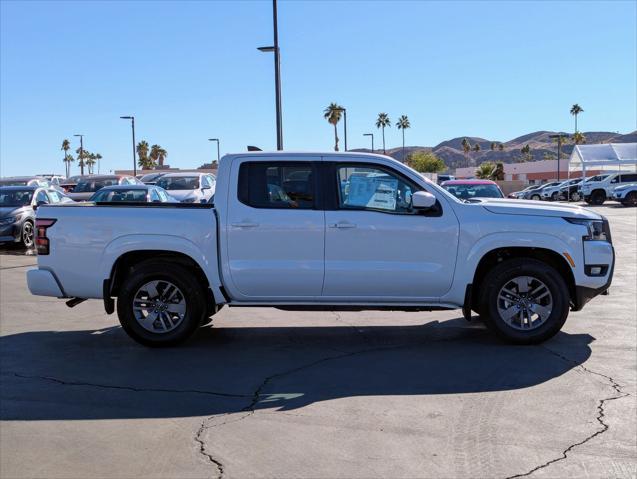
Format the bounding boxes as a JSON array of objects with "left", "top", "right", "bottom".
[{"left": 480, "top": 258, "right": 569, "bottom": 344}]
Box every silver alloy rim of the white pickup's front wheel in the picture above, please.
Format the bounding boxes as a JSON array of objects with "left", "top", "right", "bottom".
[{"left": 498, "top": 276, "right": 553, "bottom": 331}]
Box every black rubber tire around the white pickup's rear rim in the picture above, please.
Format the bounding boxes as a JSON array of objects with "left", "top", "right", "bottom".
[{"left": 117, "top": 260, "right": 207, "bottom": 347}]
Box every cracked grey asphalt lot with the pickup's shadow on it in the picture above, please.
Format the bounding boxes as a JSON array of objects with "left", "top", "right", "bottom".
[{"left": 0, "top": 204, "right": 637, "bottom": 478}]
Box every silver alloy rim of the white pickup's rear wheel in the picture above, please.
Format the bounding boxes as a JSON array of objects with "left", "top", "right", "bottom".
[{"left": 133, "top": 280, "right": 187, "bottom": 334}]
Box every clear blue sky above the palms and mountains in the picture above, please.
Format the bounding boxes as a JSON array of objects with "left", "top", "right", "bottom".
[{"left": 0, "top": 0, "right": 637, "bottom": 175}]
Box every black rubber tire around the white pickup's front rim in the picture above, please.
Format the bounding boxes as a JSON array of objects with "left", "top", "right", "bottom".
[{"left": 480, "top": 258, "right": 569, "bottom": 344}]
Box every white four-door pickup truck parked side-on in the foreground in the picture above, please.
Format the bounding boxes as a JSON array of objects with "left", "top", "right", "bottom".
[{"left": 27, "top": 152, "right": 615, "bottom": 346}]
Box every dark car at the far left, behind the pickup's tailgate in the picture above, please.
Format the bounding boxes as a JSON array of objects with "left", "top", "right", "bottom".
[{"left": 0, "top": 186, "right": 72, "bottom": 248}]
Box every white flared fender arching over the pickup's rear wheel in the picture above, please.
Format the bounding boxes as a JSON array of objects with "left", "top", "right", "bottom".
[{"left": 99, "top": 234, "right": 225, "bottom": 303}]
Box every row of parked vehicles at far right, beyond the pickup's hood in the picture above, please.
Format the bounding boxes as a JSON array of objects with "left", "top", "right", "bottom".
[{"left": 508, "top": 172, "right": 637, "bottom": 206}]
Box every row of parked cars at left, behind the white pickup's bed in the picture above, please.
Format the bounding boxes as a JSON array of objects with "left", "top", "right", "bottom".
[{"left": 0, "top": 172, "right": 216, "bottom": 248}]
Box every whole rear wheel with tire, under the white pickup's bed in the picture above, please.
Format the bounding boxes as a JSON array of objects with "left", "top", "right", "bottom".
[{"left": 117, "top": 261, "right": 207, "bottom": 347}]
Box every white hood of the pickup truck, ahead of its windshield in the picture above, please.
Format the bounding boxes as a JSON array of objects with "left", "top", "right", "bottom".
[{"left": 480, "top": 198, "right": 602, "bottom": 220}]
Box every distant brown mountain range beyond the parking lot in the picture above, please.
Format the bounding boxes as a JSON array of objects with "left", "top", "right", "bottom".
[{"left": 352, "top": 130, "right": 637, "bottom": 170}]
